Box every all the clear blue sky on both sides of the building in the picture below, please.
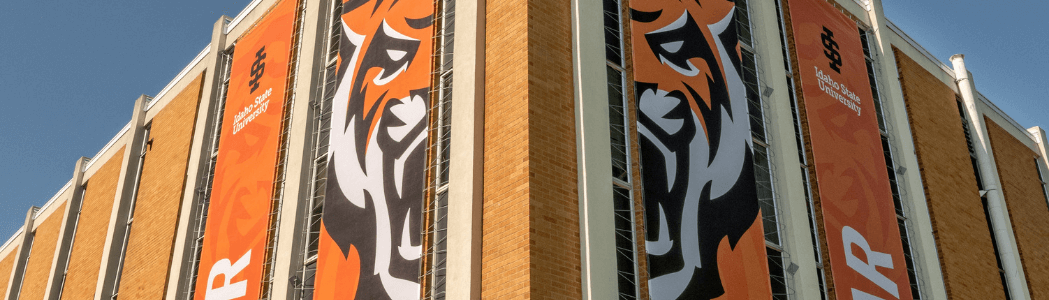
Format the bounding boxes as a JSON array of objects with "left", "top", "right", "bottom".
[{"left": 0, "top": 0, "right": 1049, "bottom": 239}]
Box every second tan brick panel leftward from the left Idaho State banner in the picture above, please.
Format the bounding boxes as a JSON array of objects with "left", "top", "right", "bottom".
[{"left": 62, "top": 147, "right": 125, "bottom": 299}]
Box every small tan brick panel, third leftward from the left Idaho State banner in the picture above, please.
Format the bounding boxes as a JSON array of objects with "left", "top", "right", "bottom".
[{"left": 18, "top": 203, "right": 66, "bottom": 300}]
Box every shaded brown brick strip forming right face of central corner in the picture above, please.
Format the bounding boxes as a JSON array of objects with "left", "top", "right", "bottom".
[{"left": 528, "top": 0, "right": 583, "bottom": 299}]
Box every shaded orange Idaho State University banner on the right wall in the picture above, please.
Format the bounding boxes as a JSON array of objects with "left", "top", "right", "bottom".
[{"left": 789, "top": 0, "right": 911, "bottom": 300}]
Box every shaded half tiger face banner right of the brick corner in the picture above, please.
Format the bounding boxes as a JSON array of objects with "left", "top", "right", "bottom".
[{"left": 630, "top": 0, "right": 772, "bottom": 300}]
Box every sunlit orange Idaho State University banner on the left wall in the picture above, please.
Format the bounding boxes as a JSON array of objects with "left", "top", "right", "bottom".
[{"left": 194, "top": 0, "right": 297, "bottom": 300}]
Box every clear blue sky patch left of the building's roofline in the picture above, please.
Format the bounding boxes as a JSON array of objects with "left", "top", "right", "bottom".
[{"left": 0, "top": 0, "right": 251, "bottom": 242}]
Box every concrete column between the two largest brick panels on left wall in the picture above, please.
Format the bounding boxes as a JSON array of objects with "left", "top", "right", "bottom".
[{"left": 94, "top": 94, "right": 149, "bottom": 299}]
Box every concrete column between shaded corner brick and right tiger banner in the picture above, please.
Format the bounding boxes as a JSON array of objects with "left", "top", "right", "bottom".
[{"left": 572, "top": 0, "right": 616, "bottom": 299}]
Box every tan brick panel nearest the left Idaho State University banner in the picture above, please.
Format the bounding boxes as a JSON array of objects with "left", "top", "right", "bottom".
[{"left": 120, "top": 73, "right": 204, "bottom": 299}]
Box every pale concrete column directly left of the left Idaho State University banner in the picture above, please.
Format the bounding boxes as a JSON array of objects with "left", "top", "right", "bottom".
[{"left": 164, "top": 16, "right": 230, "bottom": 300}]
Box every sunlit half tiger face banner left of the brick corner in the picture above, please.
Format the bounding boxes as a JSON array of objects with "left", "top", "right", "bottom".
[{"left": 314, "top": 0, "right": 434, "bottom": 300}]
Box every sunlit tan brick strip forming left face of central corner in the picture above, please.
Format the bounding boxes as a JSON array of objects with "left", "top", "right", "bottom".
[{"left": 480, "top": 0, "right": 531, "bottom": 299}]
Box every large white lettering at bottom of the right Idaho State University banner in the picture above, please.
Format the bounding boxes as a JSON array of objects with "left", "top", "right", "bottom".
[{"left": 841, "top": 227, "right": 900, "bottom": 299}]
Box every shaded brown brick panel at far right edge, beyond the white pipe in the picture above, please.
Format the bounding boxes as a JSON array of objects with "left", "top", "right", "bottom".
[{"left": 984, "top": 119, "right": 1049, "bottom": 299}]
